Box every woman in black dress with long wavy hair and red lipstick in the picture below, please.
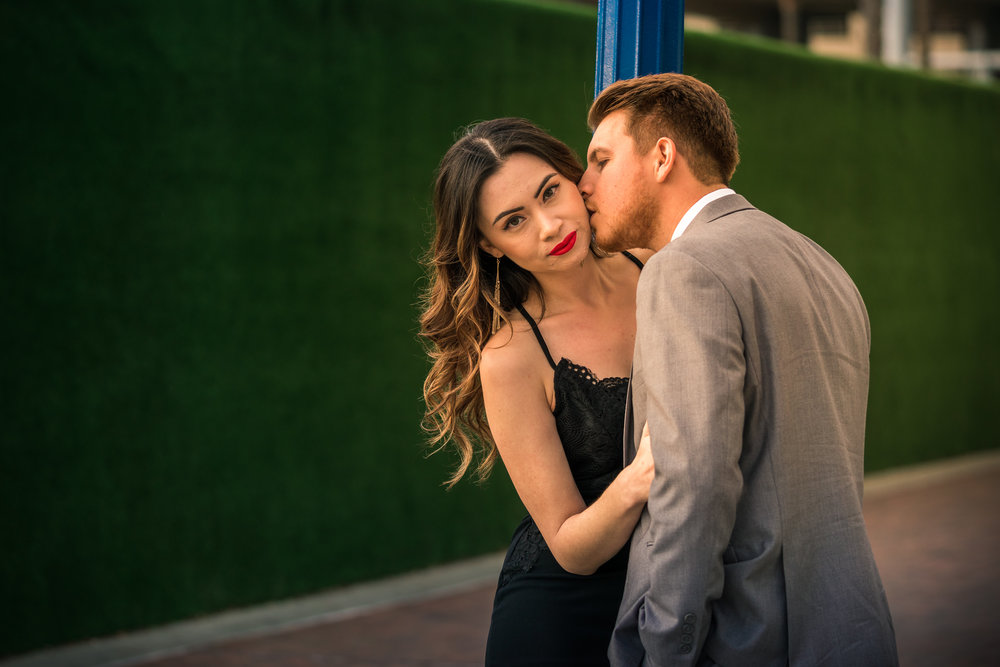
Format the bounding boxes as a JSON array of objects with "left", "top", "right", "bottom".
[{"left": 421, "top": 118, "right": 653, "bottom": 667}]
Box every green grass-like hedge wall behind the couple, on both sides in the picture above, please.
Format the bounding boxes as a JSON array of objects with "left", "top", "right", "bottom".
[{"left": 0, "top": 0, "right": 1000, "bottom": 655}]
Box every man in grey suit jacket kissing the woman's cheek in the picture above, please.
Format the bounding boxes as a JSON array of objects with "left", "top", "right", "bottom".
[{"left": 580, "top": 74, "right": 898, "bottom": 667}]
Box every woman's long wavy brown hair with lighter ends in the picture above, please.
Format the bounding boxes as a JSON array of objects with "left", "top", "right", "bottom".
[{"left": 420, "top": 118, "right": 583, "bottom": 488}]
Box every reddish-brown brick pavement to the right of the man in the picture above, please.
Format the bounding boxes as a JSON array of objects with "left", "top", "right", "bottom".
[{"left": 865, "top": 460, "right": 1000, "bottom": 667}]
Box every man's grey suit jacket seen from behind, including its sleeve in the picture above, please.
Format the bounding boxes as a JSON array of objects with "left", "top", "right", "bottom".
[{"left": 622, "top": 196, "right": 896, "bottom": 665}]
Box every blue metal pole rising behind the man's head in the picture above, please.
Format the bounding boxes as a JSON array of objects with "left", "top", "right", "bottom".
[{"left": 594, "top": 0, "right": 684, "bottom": 96}]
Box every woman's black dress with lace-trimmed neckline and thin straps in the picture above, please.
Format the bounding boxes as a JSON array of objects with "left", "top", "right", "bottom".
[{"left": 486, "top": 255, "right": 642, "bottom": 667}]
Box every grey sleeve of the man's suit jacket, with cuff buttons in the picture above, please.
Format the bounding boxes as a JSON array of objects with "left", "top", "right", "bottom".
[{"left": 636, "top": 249, "right": 746, "bottom": 665}]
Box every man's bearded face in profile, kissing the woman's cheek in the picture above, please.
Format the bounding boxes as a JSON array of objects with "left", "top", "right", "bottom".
[{"left": 578, "top": 111, "right": 659, "bottom": 252}]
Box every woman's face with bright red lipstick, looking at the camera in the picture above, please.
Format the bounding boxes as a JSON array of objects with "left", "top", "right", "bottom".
[{"left": 478, "top": 153, "right": 590, "bottom": 273}]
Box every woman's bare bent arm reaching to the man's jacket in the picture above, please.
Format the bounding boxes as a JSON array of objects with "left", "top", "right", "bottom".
[{"left": 480, "top": 345, "right": 653, "bottom": 574}]
